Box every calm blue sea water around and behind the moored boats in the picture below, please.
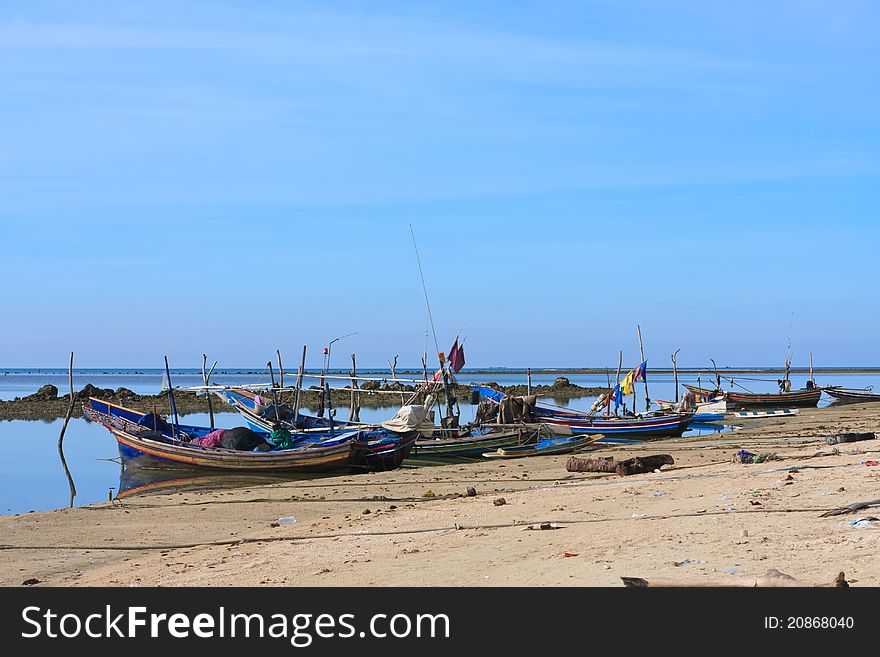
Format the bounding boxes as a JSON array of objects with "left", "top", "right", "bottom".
[{"left": 0, "top": 369, "right": 880, "bottom": 514}]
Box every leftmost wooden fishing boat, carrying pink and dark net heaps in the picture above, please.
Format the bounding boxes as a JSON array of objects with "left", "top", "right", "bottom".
[{"left": 83, "top": 398, "right": 366, "bottom": 472}]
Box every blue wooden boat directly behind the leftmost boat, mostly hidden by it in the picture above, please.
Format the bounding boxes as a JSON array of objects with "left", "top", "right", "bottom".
[{"left": 216, "top": 389, "right": 419, "bottom": 472}]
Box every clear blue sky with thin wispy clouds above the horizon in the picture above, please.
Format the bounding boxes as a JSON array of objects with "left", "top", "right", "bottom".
[{"left": 0, "top": 0, "right": 880, "bottom": 367}]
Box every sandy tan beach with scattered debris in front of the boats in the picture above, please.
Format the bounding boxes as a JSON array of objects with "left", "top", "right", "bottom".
[{"left": 0, "top": 405, "right": 880, "bottom": 586}]
